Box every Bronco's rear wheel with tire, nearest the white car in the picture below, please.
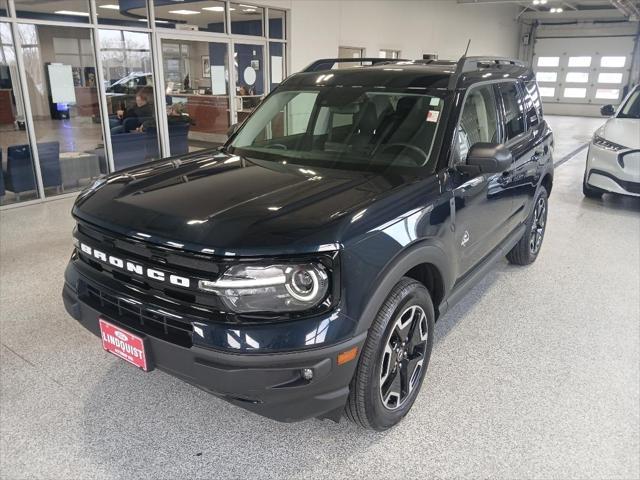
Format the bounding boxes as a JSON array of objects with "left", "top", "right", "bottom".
[{"left": 507, "top": 185, "right": 548, "bottom": 265}]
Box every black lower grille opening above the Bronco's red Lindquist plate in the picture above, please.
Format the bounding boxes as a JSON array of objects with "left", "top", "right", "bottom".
[{"left": 78, "top": 281, "right": 193, "bottom": 348}]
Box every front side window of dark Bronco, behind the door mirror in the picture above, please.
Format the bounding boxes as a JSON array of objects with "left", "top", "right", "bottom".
[{"left": 454, "top": 85, "right": 498, "bottom": 164}]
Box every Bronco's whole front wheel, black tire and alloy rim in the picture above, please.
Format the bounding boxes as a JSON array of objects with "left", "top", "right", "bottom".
[{"left": 345, "top": 277, "right": 435, "bottom": 431}]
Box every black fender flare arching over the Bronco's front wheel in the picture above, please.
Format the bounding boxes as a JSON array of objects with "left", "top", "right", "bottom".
[{"left": 355, "top": 240, "right": 455, "bottom": 335}]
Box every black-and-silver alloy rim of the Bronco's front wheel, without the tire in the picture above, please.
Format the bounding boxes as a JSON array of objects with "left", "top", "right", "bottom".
[{"left": 380, "top": 305, "right": 429, "bottom": 410}]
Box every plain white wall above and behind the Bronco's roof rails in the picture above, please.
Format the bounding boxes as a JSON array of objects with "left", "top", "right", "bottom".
[{"left": 249, "top": 0, "right": 520, "bottom": 72}]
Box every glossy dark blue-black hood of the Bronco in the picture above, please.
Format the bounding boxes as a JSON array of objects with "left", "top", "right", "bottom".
[{"left": 73, "top": 152, "right": 418, "bottom": 255}]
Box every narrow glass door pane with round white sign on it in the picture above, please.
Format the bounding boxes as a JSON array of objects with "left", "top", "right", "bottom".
[{"left": 233, "top": 42, "right": 266, "bottom": 122}]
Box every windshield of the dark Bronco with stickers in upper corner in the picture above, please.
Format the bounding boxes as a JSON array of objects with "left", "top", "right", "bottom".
[{"left": 229, "top": 86, "right": 443, "bottom": 170}]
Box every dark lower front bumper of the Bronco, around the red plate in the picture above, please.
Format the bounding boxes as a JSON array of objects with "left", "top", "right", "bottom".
[{"left": 62, "top": 264, "right": 366, "bottom": 422}]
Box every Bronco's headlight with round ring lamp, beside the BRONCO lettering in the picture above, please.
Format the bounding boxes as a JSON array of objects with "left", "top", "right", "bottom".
[{"left": 198, "top": 263, "right": 329, "bottom": 313}]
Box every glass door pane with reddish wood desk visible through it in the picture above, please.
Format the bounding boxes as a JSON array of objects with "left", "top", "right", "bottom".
[{"left": 161, "top": 34, "right": 231, "bottom": 155}]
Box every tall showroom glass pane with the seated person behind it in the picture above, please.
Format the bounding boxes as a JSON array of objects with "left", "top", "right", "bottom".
[{"left": 99, "top": 29, "right": 161, "bottom": 170}]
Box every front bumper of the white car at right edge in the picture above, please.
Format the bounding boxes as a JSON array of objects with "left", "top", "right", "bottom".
[{"left": 585, "top": 142, "right": 640, "bottom": 197}]
